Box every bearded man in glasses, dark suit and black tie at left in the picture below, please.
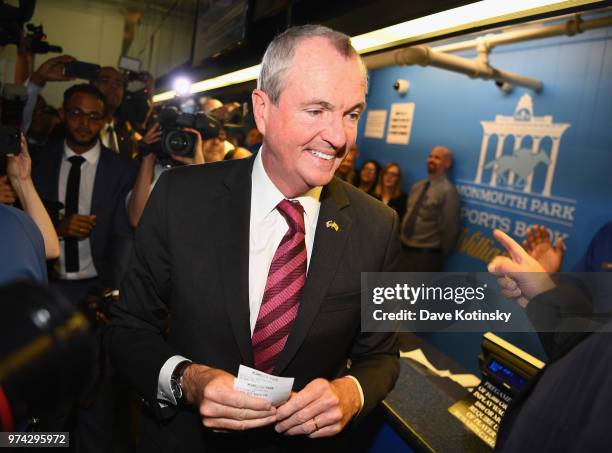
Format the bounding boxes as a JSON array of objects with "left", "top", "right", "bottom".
[{"left": 33, "top": 84, "right": 135, "bottom": 304}]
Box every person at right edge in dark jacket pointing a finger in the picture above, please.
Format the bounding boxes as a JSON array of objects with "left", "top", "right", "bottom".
[{"left": 489, "top": 230, "right": 612, "bottom": 452}]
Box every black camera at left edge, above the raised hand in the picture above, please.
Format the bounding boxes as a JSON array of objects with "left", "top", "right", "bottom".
[{"left": 0, "top": 84, "right": 28, "bottom": 175}]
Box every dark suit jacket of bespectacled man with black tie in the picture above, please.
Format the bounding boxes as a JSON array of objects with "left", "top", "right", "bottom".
[{"left": 32, "top": 142, "right": 137, "bottom": 288}]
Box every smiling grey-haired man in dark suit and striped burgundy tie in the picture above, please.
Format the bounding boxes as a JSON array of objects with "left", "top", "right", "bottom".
[{"left": 107, "top": 26, "right": 399, "bottom": 451}]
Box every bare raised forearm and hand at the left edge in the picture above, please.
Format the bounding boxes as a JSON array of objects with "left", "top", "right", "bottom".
[{"left": 0, "top": 135, "right": 60, "bottom": 259}]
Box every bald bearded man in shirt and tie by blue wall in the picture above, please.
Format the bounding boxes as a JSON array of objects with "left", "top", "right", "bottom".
[{"left": 398, "top": 146, "right": 459, "bottom": 272}]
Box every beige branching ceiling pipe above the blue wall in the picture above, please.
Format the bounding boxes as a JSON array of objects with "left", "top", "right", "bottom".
[{"left": 364, "top": 16, "right": 612, "bottom": 93}]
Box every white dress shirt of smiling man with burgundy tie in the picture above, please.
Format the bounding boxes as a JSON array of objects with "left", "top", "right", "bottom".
[{"left": 157, "top": 147, "right": 364, "bottom": 406}]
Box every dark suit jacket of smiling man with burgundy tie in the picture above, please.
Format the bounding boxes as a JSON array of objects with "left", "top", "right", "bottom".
[{"left": 107, "top": 154, "right": 399, "bottom": 452}]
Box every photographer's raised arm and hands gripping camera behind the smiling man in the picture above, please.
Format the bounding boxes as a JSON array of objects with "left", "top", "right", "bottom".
[{"left": 127, "top": 123, "right": 204, "bottom": 228}]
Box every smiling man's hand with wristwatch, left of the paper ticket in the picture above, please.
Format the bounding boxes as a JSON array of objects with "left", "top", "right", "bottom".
[{"left": 183, "top": 364, "right": 276, "bottom": 431}]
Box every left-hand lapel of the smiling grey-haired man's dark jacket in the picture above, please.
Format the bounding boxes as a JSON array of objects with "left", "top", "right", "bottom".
[{"left": 213, "top": 157, "right": 255, "bottom": 367}]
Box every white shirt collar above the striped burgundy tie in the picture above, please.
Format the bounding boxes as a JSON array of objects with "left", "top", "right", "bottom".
[{"left": 251, "top": 146, "right": 323, "bottom": 223}]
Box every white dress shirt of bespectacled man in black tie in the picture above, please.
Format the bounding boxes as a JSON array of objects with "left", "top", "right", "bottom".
[{"left": 57, "top": 141, "right": 100, "bottom": 280}]
